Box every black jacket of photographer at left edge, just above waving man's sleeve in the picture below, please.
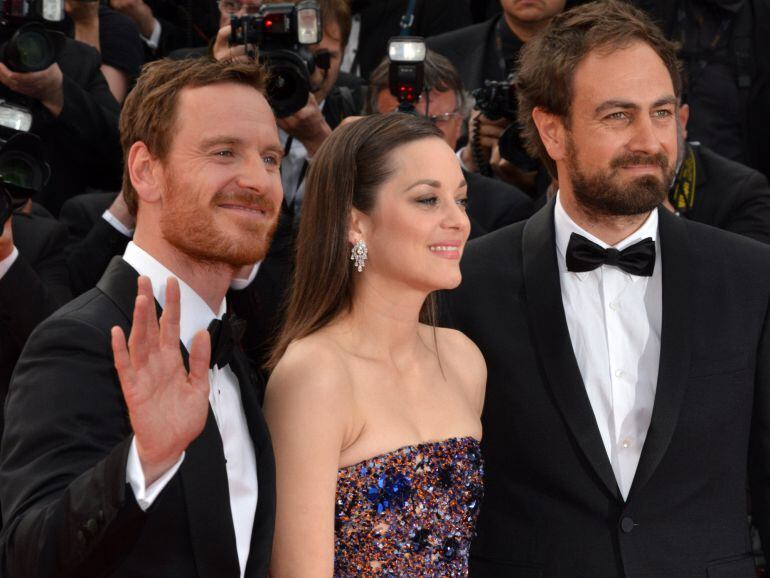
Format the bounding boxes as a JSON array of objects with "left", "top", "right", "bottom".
[{"left": 0, "top": 214, "right": 71, "bottom": 433}]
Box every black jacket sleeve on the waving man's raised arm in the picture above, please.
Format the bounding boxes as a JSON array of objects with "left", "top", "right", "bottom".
[{"left": 0, "top": 315, "right": 145, "bottom": 578}]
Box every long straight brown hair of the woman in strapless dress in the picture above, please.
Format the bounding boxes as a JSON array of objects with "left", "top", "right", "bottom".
[{"left": 268, "top": 112, "right": 442, "bottom": 368}]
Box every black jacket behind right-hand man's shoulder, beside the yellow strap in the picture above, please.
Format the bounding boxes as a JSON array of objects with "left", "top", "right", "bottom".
[{"left": 672, "top": 144, "right": 770, "bottom": 243}]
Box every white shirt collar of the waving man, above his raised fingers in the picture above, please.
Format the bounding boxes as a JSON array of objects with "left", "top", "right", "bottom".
[{"left": 123, "top": 241, "right": 227, "bottom": 351}]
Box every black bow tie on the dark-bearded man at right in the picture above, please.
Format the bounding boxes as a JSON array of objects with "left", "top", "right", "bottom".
[{"left": 567, "top": 233, "right": 655, "bottom": 277}]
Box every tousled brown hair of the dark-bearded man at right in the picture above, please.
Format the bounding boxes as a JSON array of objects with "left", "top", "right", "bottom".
[{"left": 516, "top": 0, "right": 682, "bottom": 177}]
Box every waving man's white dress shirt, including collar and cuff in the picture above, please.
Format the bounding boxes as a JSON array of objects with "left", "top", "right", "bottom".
[{"left": 123, "top": 241, "right": 257, "bottom": 577}]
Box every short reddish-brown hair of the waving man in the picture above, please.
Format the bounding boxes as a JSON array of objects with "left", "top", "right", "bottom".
[{"left": 120, "top": 58, "right": 267, "bottom": 215}]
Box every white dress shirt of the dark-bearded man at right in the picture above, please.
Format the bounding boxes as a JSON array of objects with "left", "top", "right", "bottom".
[{"left": 554, "top": 195, "right": 663, "bottom": 498}]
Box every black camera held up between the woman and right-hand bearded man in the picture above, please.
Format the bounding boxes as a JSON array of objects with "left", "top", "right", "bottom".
[{"left": 471, "top": 77, "right": 538, "bottom": 174}]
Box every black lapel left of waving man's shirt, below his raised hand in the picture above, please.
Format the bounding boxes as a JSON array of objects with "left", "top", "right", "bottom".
[{"left": 179, "top": 408, "right": 240, "bottom": 578}]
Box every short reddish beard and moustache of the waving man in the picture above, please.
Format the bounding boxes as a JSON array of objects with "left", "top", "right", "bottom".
[{"left": 160, "top": 185, "right": 278, "bottom": 269}]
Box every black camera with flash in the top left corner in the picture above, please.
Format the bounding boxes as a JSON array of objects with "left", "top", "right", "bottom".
[{"left": 0, "top": 0, "right": 65, "bottom": 72}]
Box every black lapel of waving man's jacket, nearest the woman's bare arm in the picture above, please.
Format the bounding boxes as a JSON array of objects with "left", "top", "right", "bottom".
[{"left": 230, "top": 351, "right": 275, "bottom": 578}]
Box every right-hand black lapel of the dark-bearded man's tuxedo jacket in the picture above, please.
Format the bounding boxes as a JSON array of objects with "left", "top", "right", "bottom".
[{"left": 629, "top": 209, "right": 690, "bottom": 499}]
